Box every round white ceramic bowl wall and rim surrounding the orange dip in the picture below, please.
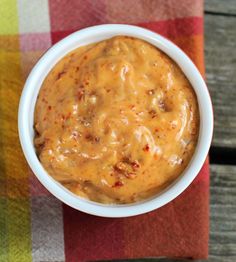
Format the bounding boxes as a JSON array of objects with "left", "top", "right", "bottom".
[{"left": 18, "top": 24, "right": 213, "bottom": 217}]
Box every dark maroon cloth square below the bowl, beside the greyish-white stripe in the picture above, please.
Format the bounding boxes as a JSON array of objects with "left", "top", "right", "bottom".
[{"left": 63, "top": 205, "right": 125, "bottom": 262}]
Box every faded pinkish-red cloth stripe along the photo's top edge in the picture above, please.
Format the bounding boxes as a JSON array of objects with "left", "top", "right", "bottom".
[{"left": 49, "top": 0, "right": 203, "bottom": 31}]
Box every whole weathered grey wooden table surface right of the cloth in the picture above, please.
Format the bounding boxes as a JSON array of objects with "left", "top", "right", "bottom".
[{"left": 205, "top": 0, "right": 236, "bottom": 262}]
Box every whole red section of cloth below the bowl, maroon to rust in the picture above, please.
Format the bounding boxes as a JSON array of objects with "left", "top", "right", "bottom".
[{"left": 63, "top": 162, "right": 209, "bottom": 262}]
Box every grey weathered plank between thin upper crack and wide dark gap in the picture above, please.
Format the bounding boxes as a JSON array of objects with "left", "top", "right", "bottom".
[{"left": 205, "top": 13, "right": 236, "bottom": 148}]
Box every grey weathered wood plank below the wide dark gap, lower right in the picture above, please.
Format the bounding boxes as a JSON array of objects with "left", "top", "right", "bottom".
[{"left": 209, "top": 165, "right": 236, "bottom": 262}]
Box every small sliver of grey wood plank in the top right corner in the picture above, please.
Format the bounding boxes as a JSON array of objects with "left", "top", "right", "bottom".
[{"left": 205, "top": 0, "right": 236, "bottom": 15}]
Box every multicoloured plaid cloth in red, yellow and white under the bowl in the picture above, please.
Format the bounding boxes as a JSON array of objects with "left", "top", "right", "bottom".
[{"left": 0, "top": 0, "right": 209, "bottom": 262}]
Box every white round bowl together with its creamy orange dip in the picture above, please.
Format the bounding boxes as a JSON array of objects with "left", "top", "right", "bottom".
[{"left": 19, "top": 25, "right": 213, "bottom": 217}]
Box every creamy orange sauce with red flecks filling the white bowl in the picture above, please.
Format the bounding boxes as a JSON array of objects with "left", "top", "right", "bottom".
[{"left": 35, "top": 36, "right": 199, "bottom": 203}]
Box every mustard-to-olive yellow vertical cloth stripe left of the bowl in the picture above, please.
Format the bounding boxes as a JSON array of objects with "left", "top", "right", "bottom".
[{"left": 0, "top": 47, "right": 32, "bottom": 262}]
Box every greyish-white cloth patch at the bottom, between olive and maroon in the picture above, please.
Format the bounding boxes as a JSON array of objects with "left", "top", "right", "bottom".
[{"left": 31, "top": 196, "right": 65, "bottom": 262}]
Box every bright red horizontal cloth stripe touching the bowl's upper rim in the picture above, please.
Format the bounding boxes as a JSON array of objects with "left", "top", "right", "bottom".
[{"left": 51, "top": 17, "right": 203, "bottom": 44}]
